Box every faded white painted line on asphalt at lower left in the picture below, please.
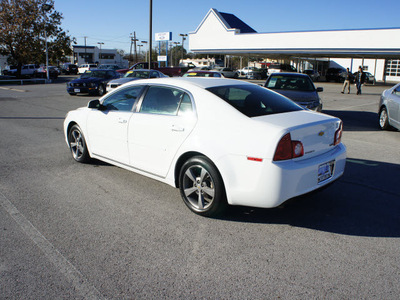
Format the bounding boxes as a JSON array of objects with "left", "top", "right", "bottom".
[{"left": 0, "top": 192, "right": 104, "bottom": 299}]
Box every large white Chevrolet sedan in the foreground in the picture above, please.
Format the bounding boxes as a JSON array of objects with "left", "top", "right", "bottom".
[{"left": 64, "top": 78, "right": 346, "bottom": 216}]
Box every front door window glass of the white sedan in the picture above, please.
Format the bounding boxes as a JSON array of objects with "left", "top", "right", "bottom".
[{"left": 102, "top": 86, "right": 143, "bottom": 111}]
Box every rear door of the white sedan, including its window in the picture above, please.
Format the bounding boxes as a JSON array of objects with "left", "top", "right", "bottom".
[{"left": 128, "top": 85, "right": 197, "bottom": 177}]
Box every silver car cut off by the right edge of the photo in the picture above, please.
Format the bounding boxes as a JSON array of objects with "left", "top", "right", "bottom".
[{"left": 378, "top": 83, "right": 400, "bottom": 130}]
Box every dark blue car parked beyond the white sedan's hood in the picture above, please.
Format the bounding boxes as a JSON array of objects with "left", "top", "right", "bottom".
[{"left": 67, "top": 69, "right": 120, "bottom": 96}]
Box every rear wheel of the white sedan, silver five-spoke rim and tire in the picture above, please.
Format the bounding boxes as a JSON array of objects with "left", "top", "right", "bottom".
[{"left": 179, "top": 156, "right": 227, "bottom": 217}]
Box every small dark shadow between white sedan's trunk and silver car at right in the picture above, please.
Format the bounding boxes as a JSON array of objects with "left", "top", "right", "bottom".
[{"left": 322, "top": 110, "right": 380, "bottom": 131}]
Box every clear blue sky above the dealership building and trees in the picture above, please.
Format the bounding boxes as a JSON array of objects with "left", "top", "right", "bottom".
[{"left": 55, "top": 0, "right": 400, "bottom": 53}]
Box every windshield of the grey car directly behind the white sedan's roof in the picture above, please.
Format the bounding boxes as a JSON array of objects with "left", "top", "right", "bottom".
[{"left": 266, "top": 75, "right": 315, "bottom": 92}]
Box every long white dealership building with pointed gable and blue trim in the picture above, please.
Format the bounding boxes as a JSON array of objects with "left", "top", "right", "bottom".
[{"left": 189, "top": 9, "right": 400, "bottom": 82}]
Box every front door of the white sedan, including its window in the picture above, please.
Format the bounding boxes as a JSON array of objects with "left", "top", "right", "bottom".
[{"left": 87, "top": 86, "right": 143, "bottom": 165}]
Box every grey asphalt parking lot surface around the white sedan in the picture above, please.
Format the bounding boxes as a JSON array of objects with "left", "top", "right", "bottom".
[{"left": 0, "top": 77, "right": 400, "bottom": 299}]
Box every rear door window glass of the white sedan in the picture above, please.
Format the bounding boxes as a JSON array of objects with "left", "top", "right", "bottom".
[{"left": 140, "top": 86, "right": 182, "bottom": 115}]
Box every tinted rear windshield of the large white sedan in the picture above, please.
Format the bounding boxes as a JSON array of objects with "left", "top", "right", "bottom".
[{"left": 207, "top": 85, "right": 303, "bottom": 117}]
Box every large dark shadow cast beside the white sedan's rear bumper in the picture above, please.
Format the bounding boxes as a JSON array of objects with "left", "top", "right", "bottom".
[{"left": 222, "top": 158, "right": 400, "bottom": 237}]
